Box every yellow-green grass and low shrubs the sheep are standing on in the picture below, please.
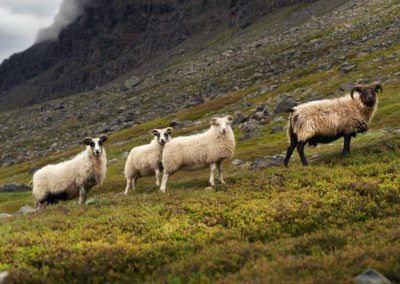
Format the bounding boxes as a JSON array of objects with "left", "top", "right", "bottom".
[{"left": 0, "top": 1, "right": 400, "bottom": 283}]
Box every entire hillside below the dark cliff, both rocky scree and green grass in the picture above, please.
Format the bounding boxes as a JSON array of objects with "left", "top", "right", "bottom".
[{"left": 0, "top": 0, "right": 400, "bottom": 283}]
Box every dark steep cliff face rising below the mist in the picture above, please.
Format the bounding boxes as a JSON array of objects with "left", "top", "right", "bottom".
[{"left": 0, "top": 0, "right": 313, "bottom": 112}]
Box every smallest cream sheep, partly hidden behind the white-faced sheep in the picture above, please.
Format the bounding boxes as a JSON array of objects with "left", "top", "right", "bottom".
[{"left": 125, "top": 127, "right": 172, "bottom": 195}]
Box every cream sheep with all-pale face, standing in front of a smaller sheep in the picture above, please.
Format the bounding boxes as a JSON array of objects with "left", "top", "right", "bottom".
[{"left": 160, "top": 116, "right": 235, "bottom": 193}]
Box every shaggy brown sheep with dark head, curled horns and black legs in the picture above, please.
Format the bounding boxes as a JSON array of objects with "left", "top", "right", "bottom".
[{"left": 284, "top": 82, "right": 383, "bottom": 167}]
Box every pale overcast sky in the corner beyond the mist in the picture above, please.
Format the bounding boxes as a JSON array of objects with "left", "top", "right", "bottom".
[{"left": 0, "top": 0, "right": 62, "bottom": 63}]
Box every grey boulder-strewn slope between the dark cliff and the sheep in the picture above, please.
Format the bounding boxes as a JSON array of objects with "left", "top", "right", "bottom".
[{"left": 0, "top": 0, "right": 400, "bottom": 167}]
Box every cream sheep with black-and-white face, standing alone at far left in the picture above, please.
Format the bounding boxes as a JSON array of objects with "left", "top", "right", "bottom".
[{"left": 32, "top": 135, "right": 107, "bottom": 210}]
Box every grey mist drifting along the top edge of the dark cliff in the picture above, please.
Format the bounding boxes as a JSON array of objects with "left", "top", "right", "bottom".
[{"left": 35, "top": 0, "right": 90, "bottom": 43}]
